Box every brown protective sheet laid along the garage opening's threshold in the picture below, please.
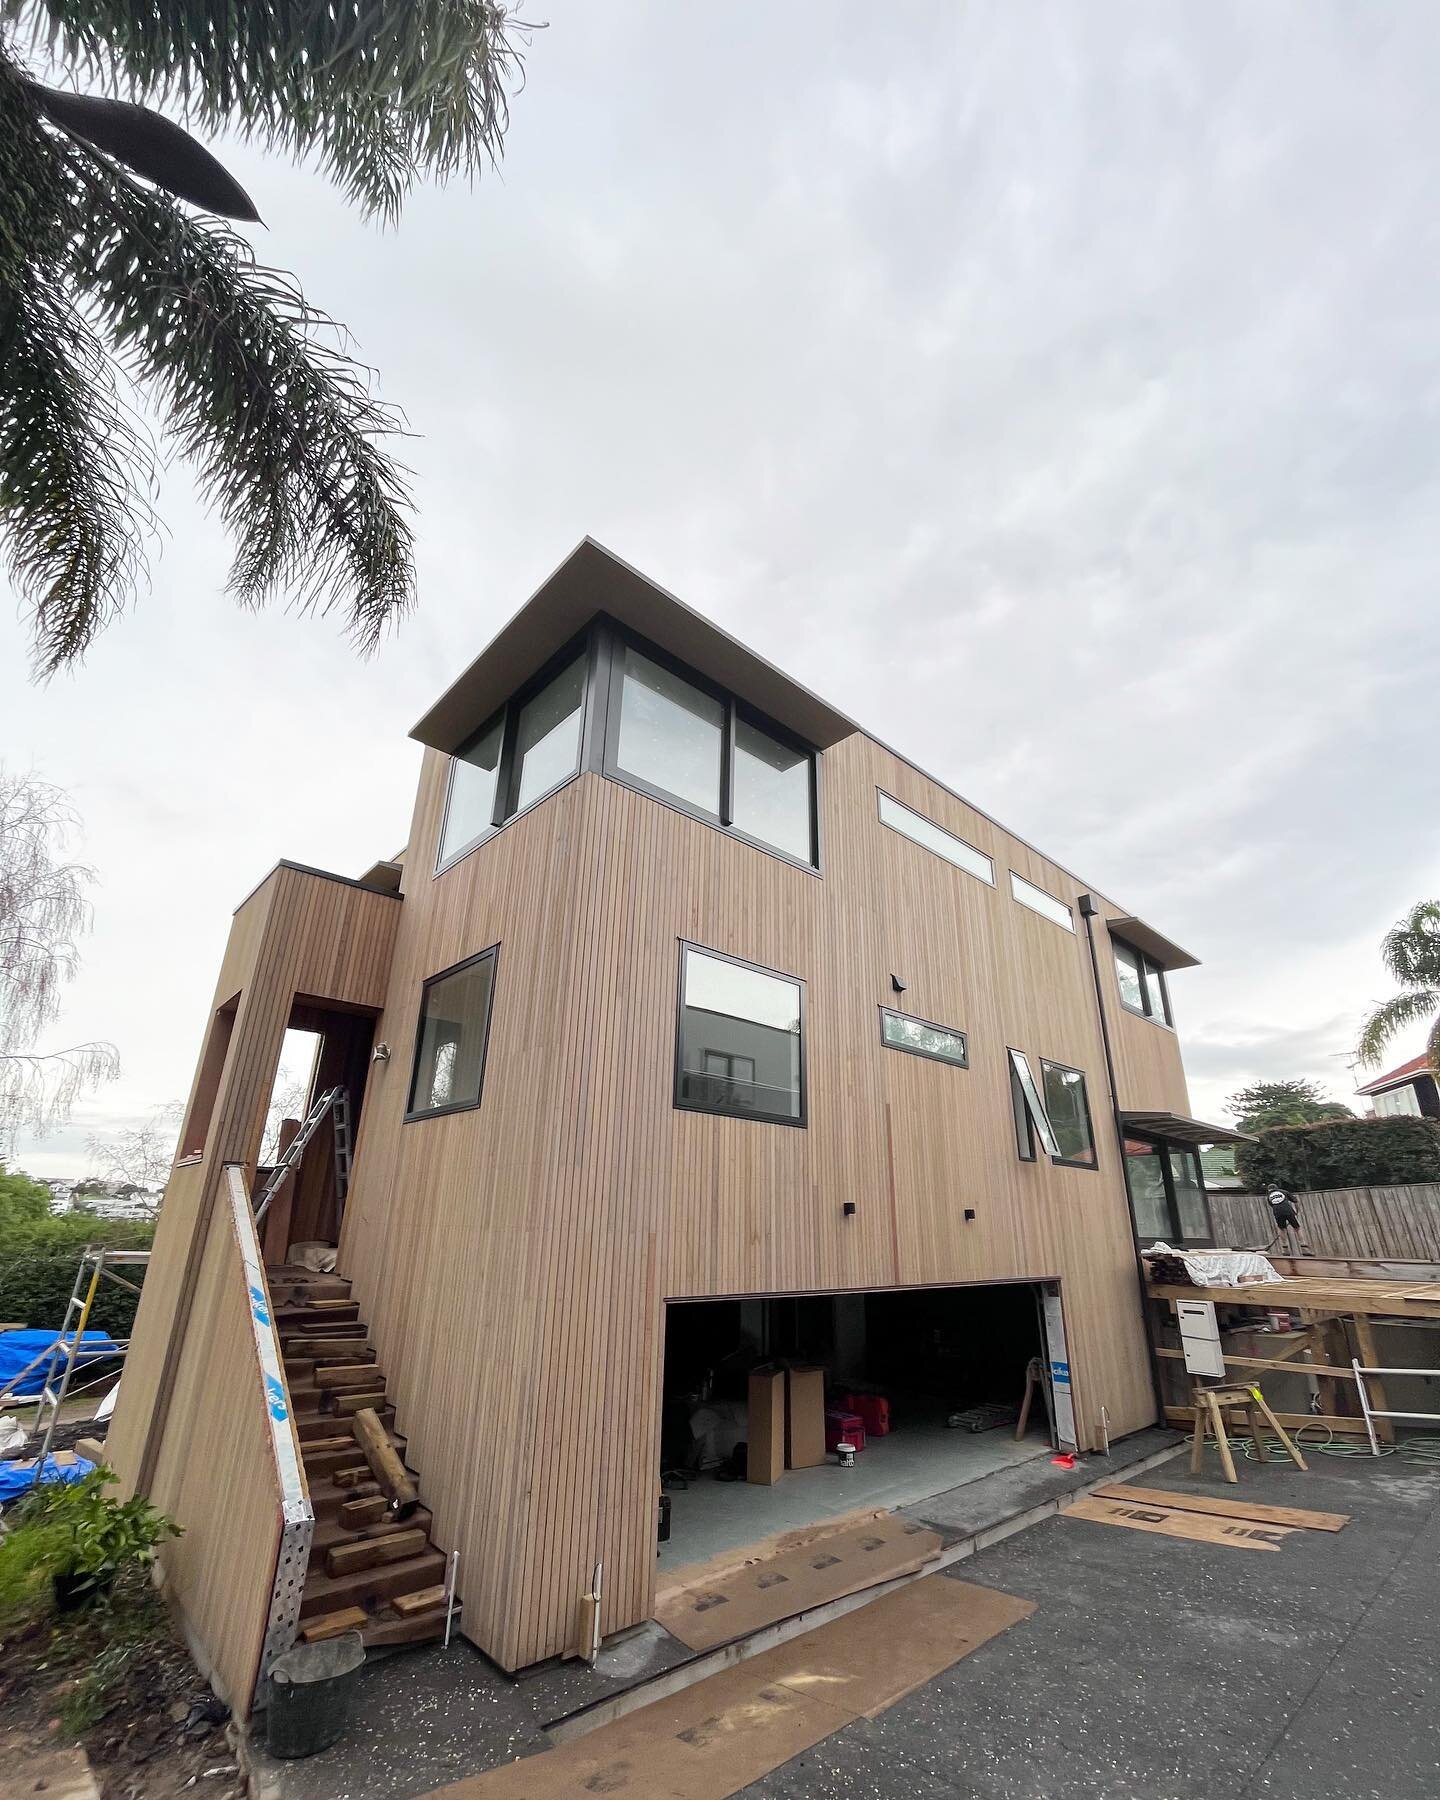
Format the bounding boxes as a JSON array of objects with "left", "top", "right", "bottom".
[{"left": 655, "top": 1514, "right": 940, "bottom": 1651}]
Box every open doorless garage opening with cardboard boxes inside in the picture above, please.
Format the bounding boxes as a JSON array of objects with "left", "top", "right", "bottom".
[{"left": 657, "top": 1282, "right": 1051, "bottom": 1575}]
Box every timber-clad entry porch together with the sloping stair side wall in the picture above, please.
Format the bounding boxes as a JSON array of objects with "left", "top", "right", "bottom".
[{"left": 108, "top": 866, "right": 400, "bottom": 1714}]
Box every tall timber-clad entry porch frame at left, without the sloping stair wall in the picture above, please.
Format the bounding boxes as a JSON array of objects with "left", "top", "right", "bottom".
[{"left": 108, "top": 864, "right": 401, "bottom": 1508}]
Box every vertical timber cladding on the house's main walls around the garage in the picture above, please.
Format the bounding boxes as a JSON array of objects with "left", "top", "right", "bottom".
[{"left": 342, "top": 720, "right": 1184, "bottom": 1667}]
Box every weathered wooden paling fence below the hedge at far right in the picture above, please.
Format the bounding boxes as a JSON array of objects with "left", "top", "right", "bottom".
[{"left": 1210, "top": 1181, "right": 1440, "bottom": 1262}]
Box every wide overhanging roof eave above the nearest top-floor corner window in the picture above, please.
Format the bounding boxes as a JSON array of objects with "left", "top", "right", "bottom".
[{"left": 410, "top": 538, "right": 859, "bottom": 754}]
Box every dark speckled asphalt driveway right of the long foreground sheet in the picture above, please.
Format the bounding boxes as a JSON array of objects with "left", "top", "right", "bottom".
[{"left": 743, "top": 1456, "right": 1440, "bottom": 1800}]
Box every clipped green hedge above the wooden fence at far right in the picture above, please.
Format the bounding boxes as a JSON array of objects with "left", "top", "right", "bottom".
[{"left": 1235, "top": 1118, "right": 1440, "bottom": 1193}]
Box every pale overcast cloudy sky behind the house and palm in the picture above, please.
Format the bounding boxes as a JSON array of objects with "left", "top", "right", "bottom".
[{"left": 0, "top": 0, "right": 1440, "bottom": 1175}]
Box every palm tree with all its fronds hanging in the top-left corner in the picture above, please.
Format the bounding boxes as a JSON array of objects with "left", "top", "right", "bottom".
[{"left": 0, "top": 0, "right": 526, "bottom": 675}]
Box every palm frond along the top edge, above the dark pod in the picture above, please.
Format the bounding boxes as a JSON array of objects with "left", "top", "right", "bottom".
[{"left": 0, "top": 0, "right": 533, "bottom": 218}]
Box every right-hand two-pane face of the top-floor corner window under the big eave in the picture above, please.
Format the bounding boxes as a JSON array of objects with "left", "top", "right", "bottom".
[{"left": 605, "top": 635, "right": 817, "bottom": 868}]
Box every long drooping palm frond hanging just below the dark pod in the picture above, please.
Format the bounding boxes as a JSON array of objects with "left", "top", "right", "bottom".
[{"left": 68, "top": 151, "right": 414, "bottom": 650}]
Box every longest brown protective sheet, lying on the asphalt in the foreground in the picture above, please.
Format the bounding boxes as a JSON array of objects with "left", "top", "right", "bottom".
[{"left": 428, "top": 1577, "right": 1035, "bottom": 1800}]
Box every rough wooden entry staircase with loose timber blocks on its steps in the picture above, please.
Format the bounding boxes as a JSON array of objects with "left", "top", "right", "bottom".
[{"left": 266, "top": 1265, "right": 461, "bottom": 1647}]
